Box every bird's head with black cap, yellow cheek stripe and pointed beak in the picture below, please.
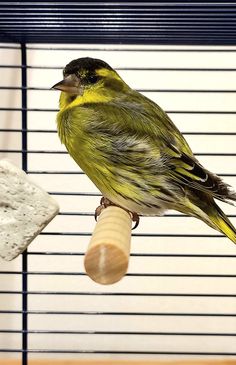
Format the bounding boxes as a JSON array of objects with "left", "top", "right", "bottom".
[{"left": 52, "top": 57, "right": 125, "bottom": 101}]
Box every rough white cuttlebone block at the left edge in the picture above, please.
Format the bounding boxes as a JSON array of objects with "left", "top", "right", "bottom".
[{"left": 0, "top": 160, "right": 59, "bottom": 261}]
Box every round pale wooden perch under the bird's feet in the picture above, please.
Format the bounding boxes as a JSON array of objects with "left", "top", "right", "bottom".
[{"left": 84, "top": 206, "right": 132, "bottom": 284}]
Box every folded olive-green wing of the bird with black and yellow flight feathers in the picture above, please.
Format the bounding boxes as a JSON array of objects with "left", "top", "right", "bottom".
[{"left": 79, "top": 98, "right": 236, "bottom": 200}]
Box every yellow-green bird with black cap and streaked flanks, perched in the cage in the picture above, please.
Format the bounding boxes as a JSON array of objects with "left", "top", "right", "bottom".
[{"left": 52, "top": 57, "right": 236, "bottom": 243}]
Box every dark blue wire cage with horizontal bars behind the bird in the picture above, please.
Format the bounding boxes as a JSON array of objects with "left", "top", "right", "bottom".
[{"left": 0, "top": 1, "right": 236, "bottom": 365}]
